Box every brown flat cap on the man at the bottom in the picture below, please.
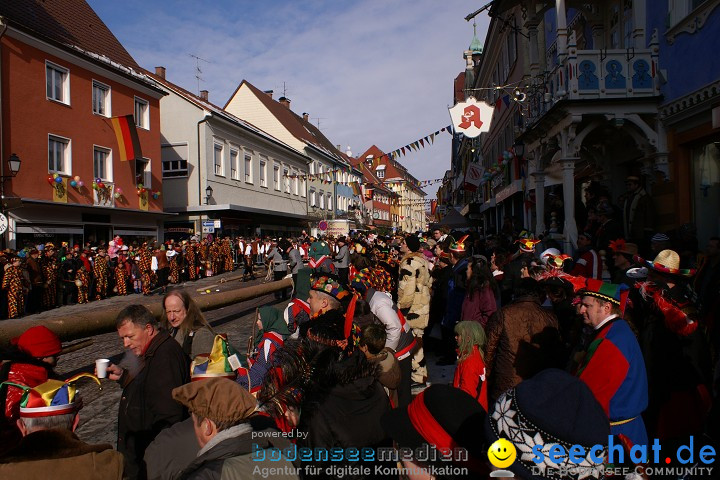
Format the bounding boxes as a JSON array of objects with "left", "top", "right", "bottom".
[{"left": 173, "top": 378, "right": 257, "bottom": 422}]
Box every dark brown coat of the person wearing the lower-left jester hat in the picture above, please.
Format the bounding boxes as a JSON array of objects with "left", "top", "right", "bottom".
[{"left": 0, "top": 428, "right": 123, "bottom": 480}]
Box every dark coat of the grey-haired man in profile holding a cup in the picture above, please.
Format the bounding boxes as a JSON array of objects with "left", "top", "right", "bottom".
[{"left": 117, "top": 331, "right": 190, "bottom": 478}]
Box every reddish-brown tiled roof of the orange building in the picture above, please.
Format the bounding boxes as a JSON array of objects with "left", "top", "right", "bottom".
[{"left": 0, "top": 0, "right": 139, "bottom": 69}]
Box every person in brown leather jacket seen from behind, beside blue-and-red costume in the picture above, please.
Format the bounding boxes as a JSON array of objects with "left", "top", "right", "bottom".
[{"left": 485, "top": 278, "right": 562, "bottom": 403}]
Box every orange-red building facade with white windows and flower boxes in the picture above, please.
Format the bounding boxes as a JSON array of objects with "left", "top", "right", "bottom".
[{"left": 0, "top": 8, "right": 166, "bottom": 249}]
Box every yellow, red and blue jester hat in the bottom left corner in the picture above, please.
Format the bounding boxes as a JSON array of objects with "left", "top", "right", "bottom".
[{"left": 2, "top": 373, "right": 100, "bottom": 418}]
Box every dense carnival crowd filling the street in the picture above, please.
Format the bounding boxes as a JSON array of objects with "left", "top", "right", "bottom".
[{"left": 0, "top": 212, "right": 720, "bottom": 478}]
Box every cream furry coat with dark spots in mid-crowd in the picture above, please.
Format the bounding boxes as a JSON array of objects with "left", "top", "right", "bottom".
[{"left": 397, "top": 252, "right": 432, "bottom": 329}]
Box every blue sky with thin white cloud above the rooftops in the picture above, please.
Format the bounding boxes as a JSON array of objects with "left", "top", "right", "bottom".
[{"left": 88, "top": 0, "right": 488, "bottom": 196}]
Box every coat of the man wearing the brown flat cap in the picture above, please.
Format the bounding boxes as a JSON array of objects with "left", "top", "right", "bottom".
[{"left": 180, "top": 415, "right": 299, "bottom": 480}]
